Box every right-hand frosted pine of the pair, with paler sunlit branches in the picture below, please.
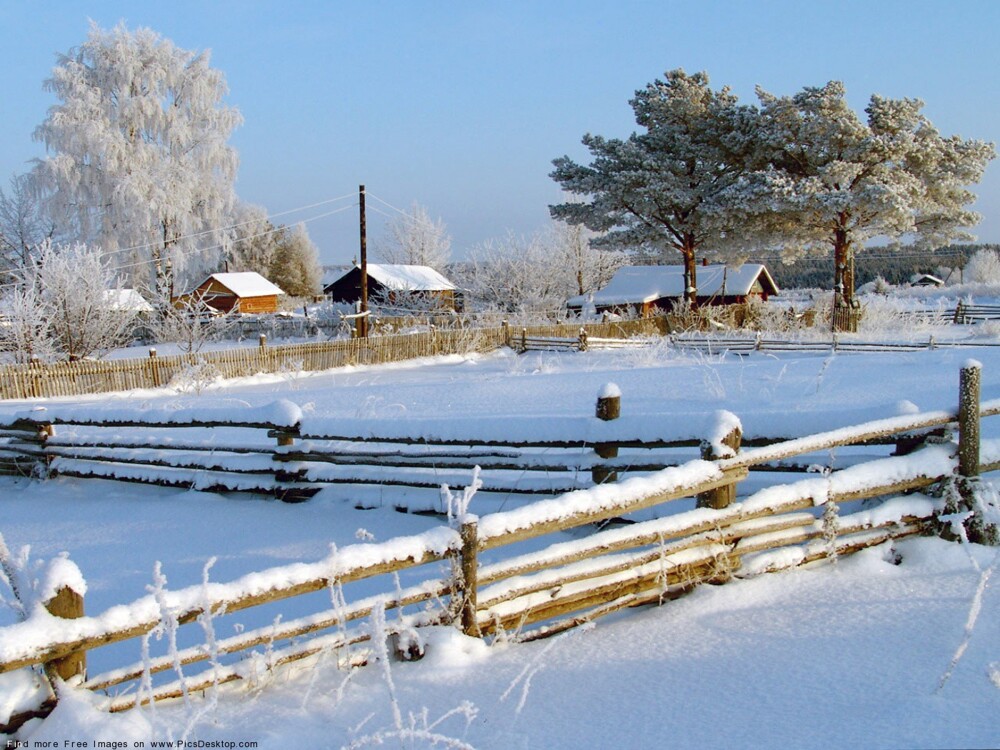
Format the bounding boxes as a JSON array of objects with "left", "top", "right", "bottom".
[{"left": 740, "top": 81, "right": 995, "bottom": 328}]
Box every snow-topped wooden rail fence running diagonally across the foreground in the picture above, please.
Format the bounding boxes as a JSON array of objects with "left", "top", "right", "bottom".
[{"left": 0, "top": 363, "right": 1000, "bottom": 732}]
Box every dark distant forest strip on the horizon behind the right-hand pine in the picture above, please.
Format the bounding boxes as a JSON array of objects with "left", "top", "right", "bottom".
[{"left": 765, "top": 244, "right": 1000, "bottom": 289}]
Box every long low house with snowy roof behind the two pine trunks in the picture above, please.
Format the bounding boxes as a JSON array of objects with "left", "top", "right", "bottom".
[{"left": 566, "top": 263, "right": 778, "bottom": 317}]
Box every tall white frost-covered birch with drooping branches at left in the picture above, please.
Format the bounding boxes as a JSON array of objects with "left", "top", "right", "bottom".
[{"left": 33, "top": 23, "right": 242, "bottom": 288}]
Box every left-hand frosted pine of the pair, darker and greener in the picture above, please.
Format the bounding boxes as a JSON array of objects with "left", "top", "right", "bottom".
[{"left": 550, "top": 70, "right": 756, "bottom": 300}]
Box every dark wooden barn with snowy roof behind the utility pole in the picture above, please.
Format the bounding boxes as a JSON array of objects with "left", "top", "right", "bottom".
[{"left": 323, "top": 263, "right": 458, "bottom": 310}]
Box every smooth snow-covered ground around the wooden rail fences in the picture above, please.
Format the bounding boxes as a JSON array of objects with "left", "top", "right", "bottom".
[{"left": 0, "top": 347, "right": 1000, "bottom": 748}]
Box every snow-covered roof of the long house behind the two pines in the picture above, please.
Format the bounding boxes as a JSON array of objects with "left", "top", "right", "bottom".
[{"left": 566, "top": 263, "right": 777, "bottom": 307}]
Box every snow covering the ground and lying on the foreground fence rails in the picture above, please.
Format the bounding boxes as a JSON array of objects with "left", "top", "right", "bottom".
[{"left": 0, "top": 344, "right": 1000, "bottom": 750}]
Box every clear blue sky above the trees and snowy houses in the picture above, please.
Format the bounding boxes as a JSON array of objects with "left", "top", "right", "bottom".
[{"left": 0, "top": 0, "right": 1000, "bottom": 264}]
